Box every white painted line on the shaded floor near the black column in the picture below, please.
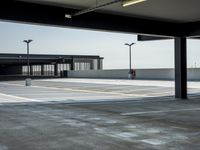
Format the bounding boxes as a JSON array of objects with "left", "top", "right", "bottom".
[{"left": 120, "top": 108, "right": 200, "bottom": 116}]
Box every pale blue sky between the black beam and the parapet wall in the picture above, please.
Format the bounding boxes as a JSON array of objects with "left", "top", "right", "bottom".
[{"left": 0, "top": 22, "right": 200, "bottom": 69}]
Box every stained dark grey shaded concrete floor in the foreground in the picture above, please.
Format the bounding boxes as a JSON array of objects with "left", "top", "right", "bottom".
[{"left": 0, "top": 99, "right": 200, "bottom": 150}]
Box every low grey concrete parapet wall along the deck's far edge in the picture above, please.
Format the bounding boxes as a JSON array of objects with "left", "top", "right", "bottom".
[{"left": 68, "top": 68, "right": 200, "bottom": 81}]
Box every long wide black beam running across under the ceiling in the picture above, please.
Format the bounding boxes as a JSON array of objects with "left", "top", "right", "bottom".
[{"left": 0, "top": 0, "right": 188, "bottom": 36}]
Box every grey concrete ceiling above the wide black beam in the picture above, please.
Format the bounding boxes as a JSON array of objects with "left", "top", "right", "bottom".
[{"left": 21, "top": 0, "right": 200, "bottom": 23}]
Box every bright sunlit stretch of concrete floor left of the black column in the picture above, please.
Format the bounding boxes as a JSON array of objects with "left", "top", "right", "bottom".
[{"left": 0, "top": 79, "right": 174, "bottom": 103}]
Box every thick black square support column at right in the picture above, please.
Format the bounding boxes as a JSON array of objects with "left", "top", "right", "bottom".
[{"left": 175, "top": 37, "right": 187, "bottom": 99}]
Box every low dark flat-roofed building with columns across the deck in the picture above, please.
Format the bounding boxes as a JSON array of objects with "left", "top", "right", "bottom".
[{"left": 0, "top": 54, "right": 103, "bottom": 76}]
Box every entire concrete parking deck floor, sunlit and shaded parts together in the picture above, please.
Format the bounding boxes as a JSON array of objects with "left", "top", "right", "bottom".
[{"left": 0, "top": 80, "right": 200, "bottom": 150}]
